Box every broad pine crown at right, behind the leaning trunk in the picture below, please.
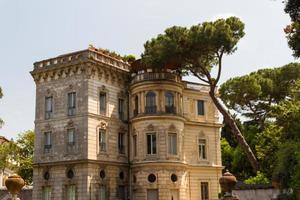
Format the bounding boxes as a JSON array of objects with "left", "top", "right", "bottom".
[{"left": 219, "top": 63, "right": 300, "bottom": 125}]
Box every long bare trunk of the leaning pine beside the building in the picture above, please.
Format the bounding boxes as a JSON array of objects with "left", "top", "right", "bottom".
[{"left": 209, "top": 88, "right": 259, "bottom": 173}]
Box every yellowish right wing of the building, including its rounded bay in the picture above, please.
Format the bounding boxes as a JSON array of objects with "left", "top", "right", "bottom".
[{"left": 129, "top": 60, "right": 222, "bottom": 200}]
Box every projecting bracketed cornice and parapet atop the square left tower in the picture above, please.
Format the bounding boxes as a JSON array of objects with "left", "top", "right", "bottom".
[{"left": 30, "top": 49, "right": 129, "bottom": 84}]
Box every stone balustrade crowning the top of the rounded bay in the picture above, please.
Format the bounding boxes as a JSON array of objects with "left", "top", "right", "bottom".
[{"left": 131, "top": 72, "right": 181, "bottom": 84}]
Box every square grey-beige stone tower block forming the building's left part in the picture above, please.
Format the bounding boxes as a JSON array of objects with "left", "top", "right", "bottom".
[{"left": 31, "top": 47, "right": 129, "bottom": 200}]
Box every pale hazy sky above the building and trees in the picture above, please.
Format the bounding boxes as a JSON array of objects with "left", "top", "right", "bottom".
[{"left": 0, "top": 0, "right": 295, "bottom": 139}]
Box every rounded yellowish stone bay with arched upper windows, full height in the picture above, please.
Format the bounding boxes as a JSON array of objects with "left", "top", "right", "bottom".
[{"left": 130, "top": 61, "right": 187, "bottom": 199}]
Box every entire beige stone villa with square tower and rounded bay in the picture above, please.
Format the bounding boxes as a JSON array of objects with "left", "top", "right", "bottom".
[{"left": 31, "top": 47, "right": 222, "bottom": 200}]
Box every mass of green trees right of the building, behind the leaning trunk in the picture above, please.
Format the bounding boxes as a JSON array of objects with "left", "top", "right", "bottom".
[{"left": 220, "top": 63, "right": 300, "bottom": 192}]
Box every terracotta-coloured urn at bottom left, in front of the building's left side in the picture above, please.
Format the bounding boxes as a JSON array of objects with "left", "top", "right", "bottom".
[{"left": 5, "top": 174, "right": 25, "bottom": 200}]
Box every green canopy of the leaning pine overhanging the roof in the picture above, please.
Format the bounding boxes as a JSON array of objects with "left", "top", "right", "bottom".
[{"left": 142, "top": 17, "right": 245, "bottom": 81}]
